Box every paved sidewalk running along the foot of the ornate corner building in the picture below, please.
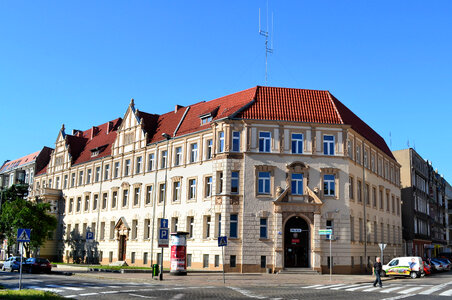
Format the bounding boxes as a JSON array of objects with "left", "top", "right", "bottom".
[{"left": 54, "top": 267, "right": 393, "bottom": 286}]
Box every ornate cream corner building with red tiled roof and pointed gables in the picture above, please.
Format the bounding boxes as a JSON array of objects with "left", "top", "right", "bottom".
[{"left": 34, "top": 86, "right": 402, "bottom": 273}]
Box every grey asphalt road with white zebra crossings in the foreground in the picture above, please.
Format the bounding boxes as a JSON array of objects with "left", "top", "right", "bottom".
[{"left": 0, "top": 272, "right": 452, "bottom": 300}]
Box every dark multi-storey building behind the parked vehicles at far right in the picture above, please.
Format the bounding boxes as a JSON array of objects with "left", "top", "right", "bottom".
[{"left": 393, "top": 148, "right": 447, "bottom": 257}]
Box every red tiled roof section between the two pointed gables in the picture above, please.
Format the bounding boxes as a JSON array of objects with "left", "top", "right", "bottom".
[{"left": 66, "top": 118, "right": 122, "bottom": 165}]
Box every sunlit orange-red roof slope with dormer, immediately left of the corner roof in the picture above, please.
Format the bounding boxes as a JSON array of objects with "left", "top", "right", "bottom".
[{"left": 176, "top": 87, "right": 257, "bottom": 136}]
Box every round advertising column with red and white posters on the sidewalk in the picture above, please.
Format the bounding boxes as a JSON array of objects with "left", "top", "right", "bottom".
[{"left": 170, "top": 232, "right": 188, "bottom": 275}]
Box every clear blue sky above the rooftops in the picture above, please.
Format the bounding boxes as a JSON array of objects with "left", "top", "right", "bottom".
[{"left": 0, "top": 0, "right": 452, "bottom": 181}]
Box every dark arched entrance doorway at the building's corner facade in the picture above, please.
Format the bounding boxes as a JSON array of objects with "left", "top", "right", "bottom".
[{"left": 284, "top": 217, "right": 311, "bottom": 268}]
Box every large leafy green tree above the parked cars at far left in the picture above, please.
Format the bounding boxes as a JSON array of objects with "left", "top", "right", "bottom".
[{"left": 0, "top": 197, "right": 57, "bottom": 256}]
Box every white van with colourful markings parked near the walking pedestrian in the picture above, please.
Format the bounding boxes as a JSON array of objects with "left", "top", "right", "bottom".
[{"left": 383, "top": 256, "right": 424, "bottom": 278}]
